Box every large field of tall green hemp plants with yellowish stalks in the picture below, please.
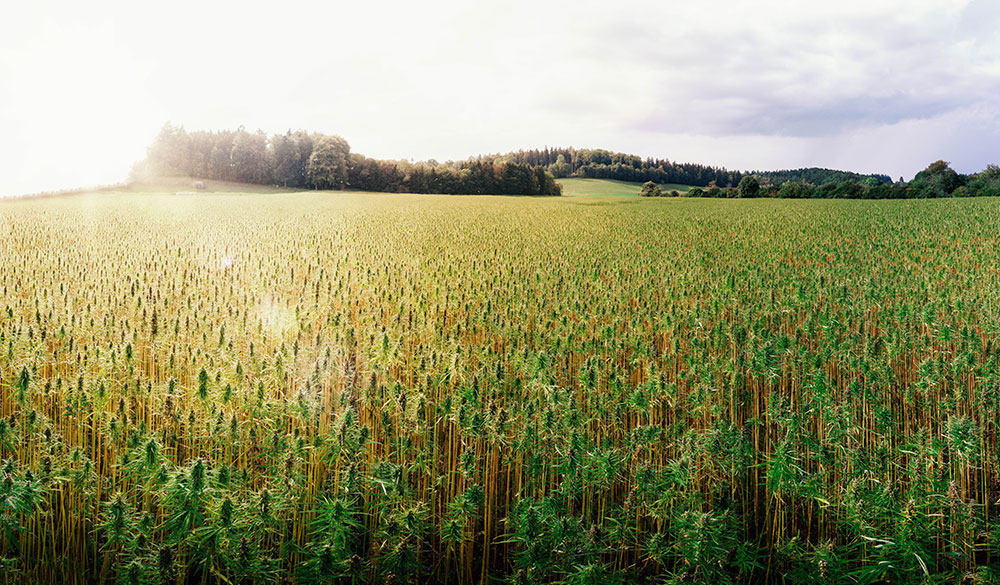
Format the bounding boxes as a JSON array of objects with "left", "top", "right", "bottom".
[{"left": 0, "top": 187, "right": 1000, "bottom": 584}]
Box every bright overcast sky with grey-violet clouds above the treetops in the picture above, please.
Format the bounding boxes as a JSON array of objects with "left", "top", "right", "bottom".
[{"left": 0, "top": 0, "right": 1000, "bottom": 194}]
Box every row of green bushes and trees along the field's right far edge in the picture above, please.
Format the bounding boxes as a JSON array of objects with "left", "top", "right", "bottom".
[{"left": 639, "top": 160, "right": 1000, "bottom": 199}]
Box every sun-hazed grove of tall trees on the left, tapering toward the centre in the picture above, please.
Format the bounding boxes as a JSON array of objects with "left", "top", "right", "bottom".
[{"left": 136, "top": 122, "right": 561, "bottom": 195}]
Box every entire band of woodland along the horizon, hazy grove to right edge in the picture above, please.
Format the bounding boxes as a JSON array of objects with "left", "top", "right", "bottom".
[{"left": 144, "top": 122, "right": 1000, "bottom": 199}]
